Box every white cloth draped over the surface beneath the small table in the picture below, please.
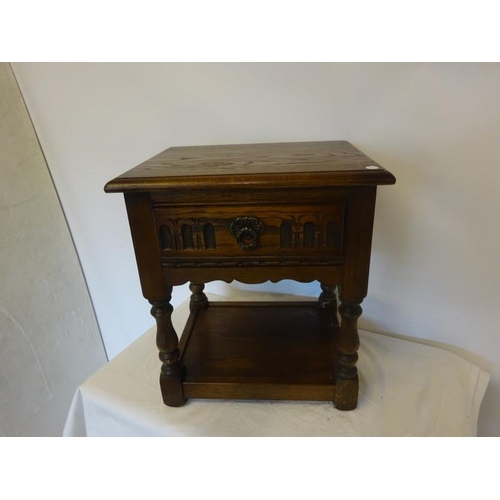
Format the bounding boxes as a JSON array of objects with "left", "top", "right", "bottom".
[{"left": 64, "top": 293, "right": 489, "bottom": 436}]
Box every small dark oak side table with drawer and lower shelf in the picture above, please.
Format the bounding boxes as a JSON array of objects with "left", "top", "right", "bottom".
[{"left": 105, "top": 141, "right": 395, "bottom": 410}]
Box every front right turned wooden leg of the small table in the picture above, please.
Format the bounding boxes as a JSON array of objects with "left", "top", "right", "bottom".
[{"left": 334, "top": 297, "right": 362, "bottom": 410}]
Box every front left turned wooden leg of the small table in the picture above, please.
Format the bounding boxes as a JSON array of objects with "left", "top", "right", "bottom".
[{"left": 150, "top": 287, "right": 186, "bottom": 406}]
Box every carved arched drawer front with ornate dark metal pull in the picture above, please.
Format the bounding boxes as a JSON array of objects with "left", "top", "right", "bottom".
[{"left": 154, "top": 201, "right": 344, "bottom": 265}]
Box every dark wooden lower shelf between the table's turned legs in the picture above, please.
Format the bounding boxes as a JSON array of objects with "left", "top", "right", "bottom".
[{"left": 179, "top": 302, "right": 336, "bottom": 401}]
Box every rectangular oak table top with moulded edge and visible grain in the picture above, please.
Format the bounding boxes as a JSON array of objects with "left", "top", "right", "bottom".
[{"left": 105, "top": 141, "right": 396, "bottom": 192}]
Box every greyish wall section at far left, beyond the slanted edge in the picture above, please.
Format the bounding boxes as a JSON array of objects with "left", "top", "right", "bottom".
[{"left": 0, "top": 63, "right": 106, "bottom": 436}]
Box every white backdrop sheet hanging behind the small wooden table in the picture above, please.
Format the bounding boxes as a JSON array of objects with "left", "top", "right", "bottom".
[{"left": 9, "top": 63, "right": 500, "bottom": 435}]
